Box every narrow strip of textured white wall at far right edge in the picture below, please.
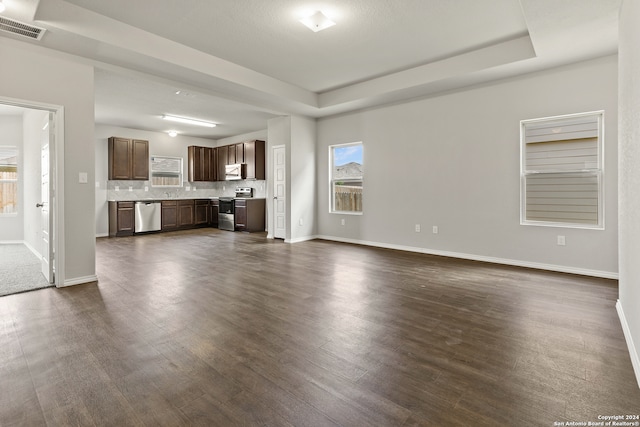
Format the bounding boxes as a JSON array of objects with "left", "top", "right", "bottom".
[{"left": 618, "top": 0, "right": 640, "bottom": 384}]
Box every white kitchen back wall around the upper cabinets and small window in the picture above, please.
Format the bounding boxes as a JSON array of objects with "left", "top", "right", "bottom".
[{"left": 95, "top": 124, "right": 217, "bottom": 236}]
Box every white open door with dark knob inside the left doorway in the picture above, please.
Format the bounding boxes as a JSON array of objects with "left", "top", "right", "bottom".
[{"left": 38, "top": 113, "right": 54, "bottom": 283}]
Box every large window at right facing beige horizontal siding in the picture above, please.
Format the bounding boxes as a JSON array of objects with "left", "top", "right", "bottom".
[{"left": 520, "top": 111, "right": 604, "bottom": 229}]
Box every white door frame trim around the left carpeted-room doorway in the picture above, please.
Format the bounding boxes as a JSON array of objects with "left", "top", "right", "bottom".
[{"left": 0, "top": 96, "right": 65, "bottom": 288}]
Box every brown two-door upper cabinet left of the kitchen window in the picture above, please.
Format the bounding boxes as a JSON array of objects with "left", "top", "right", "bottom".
[{"left": 109, "top": 137, "right": 149, "bottom": 181}]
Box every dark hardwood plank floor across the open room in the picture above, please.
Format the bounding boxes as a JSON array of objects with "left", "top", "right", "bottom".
[{"left": 0, "top": 229, "right": 640, "bottom": 426}]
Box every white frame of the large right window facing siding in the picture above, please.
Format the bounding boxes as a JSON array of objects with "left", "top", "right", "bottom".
[{"left": 520, "top": 110, "right": 605, "bottom": 230}]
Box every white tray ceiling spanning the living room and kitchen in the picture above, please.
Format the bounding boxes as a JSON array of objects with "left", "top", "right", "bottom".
[{"left": 0, "top": 0, "right": 620, "bottom": 139}]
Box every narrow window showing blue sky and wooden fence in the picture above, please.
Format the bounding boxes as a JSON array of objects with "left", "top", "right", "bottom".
[{"left": 329, "top": 142, "right": 363, "bottom": 214}]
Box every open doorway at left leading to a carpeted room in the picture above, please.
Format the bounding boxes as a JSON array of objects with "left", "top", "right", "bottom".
[{"left": 0, "top": 97, "right": 64, "bottom": 296}]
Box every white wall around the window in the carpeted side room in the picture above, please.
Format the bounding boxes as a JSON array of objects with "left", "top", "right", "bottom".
[{"left": 0, "top": 114, "right": 25, "bottom": 242}]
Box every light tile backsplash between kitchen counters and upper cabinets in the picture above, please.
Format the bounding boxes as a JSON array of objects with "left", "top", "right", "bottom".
[{"left": 107, "top": 180, "right": 267, "bottom": 201}]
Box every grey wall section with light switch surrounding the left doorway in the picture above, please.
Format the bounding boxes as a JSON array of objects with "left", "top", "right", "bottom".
[{"left": 0, "top": 37, "right": 95, "bottom": 285}]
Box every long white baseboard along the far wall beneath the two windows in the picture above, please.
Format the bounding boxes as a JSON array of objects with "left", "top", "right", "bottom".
[{"left": 316, "top": 235, "right": 618, "bottom": 280}]
